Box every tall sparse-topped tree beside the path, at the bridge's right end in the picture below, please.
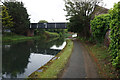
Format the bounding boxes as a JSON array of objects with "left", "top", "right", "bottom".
[{"left": 65, "top": 0, "right": 101, "bottom": 38}]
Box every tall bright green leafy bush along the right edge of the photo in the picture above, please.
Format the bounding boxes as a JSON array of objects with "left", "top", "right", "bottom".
[{"left": 109, "top": 2, "right": 120, "bottom": 68}]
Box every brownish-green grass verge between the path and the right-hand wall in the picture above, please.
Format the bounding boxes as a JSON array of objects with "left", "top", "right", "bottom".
[{"left": 81, "top": 37, "right": 118, "bottom": 78}]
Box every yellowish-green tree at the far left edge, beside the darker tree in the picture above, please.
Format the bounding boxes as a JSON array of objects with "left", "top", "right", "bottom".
[{"left": 0, "top": 6, "right": 13, "bottom": 32}]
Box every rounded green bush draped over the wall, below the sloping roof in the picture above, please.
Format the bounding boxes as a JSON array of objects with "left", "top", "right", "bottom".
[{"left": 90, "top": 14, "right": 110, "bottom": 43}]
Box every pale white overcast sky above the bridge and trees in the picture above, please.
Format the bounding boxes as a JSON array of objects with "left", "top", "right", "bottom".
[{"left": 1, "top": 0, "right": 120, "bottom": 23}]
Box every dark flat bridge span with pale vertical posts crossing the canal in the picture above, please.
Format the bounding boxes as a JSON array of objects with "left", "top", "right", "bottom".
[{"left": 30, "top": 22, "right": 67, "bottom": 29}]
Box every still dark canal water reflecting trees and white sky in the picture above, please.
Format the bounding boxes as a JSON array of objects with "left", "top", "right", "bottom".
[{"left": 2, "top": 38, "right": 66, "bottom": 78}]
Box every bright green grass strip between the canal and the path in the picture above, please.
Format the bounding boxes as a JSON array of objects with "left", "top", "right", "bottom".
[{"left": 29, "top": 40, "right": 73, "bottom": 78}]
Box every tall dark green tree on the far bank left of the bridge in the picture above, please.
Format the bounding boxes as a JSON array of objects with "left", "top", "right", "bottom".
[{"left": 4, "top": 1, "right": 30, "bottom": 35}]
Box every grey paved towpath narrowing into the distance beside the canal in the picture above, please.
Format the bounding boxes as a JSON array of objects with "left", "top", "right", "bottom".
[{"left": 62, "top": 40, "right": 98, "bottom": 78}]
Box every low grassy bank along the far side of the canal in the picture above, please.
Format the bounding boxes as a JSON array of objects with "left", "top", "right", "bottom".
[{"left": 2, "top": 32, "right": 59, "bottom": 42}]
